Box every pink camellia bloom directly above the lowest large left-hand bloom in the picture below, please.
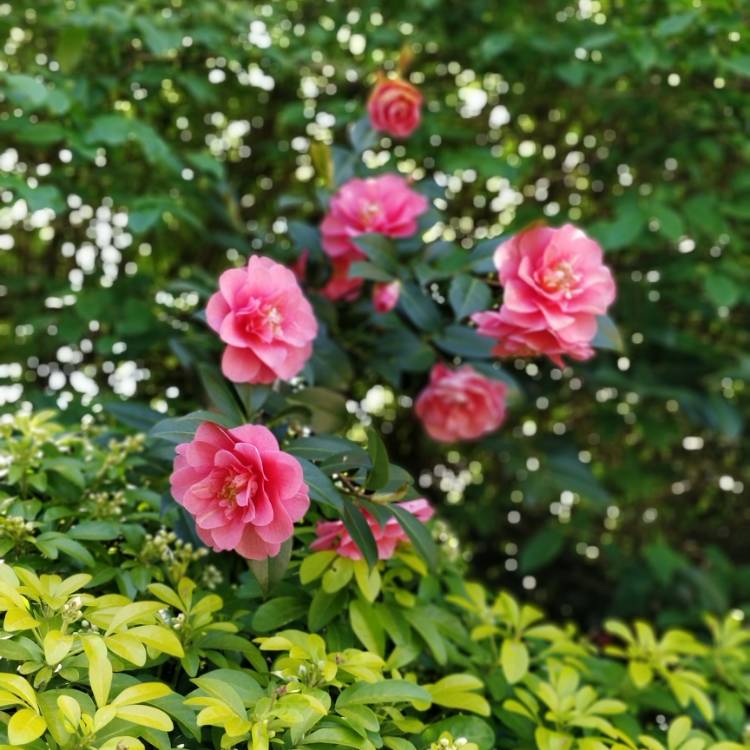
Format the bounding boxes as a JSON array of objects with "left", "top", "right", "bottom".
[{"left": 206, "top": 255, "right": 318, "bottom": 383}]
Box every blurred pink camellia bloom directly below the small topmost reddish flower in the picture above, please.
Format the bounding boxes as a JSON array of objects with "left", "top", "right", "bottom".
[{"left": 320, "top": 174, "right": 428, "bottom": 261}]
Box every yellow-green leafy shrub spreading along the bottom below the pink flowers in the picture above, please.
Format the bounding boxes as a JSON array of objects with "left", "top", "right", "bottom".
[{"left": 0, "top": 414, "right": 750, "bottom": 750}]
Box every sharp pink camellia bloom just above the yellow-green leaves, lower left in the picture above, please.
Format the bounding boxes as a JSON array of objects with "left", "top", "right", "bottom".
[{"left": 170, "top": 422, "right": 310, "bottom": 560}]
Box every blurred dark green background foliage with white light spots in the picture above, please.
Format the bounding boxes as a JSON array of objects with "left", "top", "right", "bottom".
[{"left": 0, "top": 0, "right": 750, "bottom": 626}]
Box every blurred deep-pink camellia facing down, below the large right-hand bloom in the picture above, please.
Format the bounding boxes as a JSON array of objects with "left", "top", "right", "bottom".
[{"left": 414, "top": 363, "right": 508, "bottom": 443}]
